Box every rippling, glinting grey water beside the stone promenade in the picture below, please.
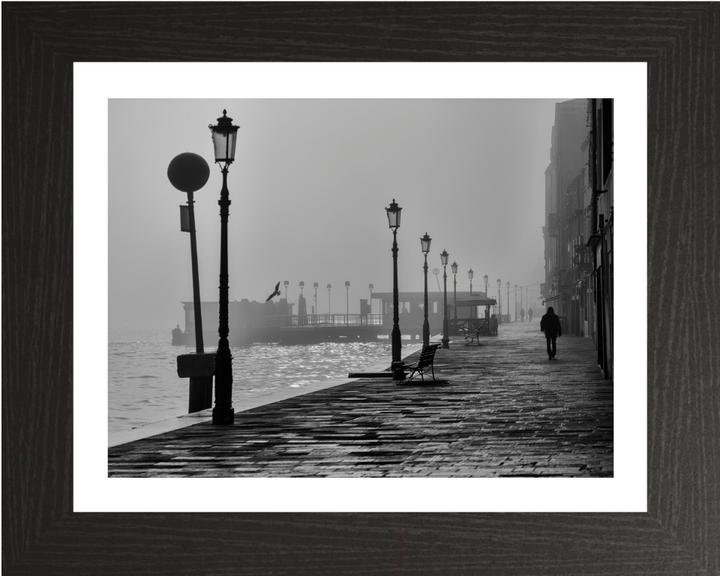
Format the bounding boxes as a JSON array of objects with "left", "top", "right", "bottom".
[{"left": 108, "top": 329, "right": 392, "bottom": 434}]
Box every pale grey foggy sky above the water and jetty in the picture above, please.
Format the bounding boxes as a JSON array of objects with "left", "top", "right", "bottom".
[{"left": 108, "top": 99, "right": 559, "bottom": 329}]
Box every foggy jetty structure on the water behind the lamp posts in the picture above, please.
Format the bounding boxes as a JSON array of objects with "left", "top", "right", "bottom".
[{"left": 172, "top": 292, "right": 496, "bottom": 346}]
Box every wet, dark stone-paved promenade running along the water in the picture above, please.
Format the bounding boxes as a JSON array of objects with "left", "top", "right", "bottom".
[{"left": 109, "top": 321, "right": 613, "bottom": 477}]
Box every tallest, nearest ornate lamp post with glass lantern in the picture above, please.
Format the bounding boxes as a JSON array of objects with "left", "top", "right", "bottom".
[{"left": 208, "top": 110, "right": 239, "bottom": 425}]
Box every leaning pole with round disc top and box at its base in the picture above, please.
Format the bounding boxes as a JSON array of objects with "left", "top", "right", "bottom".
[{"left": 167, "top": 152, "right": 215, "bottom": 413}]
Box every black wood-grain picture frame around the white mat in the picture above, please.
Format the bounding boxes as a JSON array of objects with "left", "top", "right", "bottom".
[{"left": 2, "top": 2, "right": 720, "bottom": 576}]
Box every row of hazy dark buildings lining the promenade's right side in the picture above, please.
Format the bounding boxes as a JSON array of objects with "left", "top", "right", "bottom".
[{"left": 541, "top": 99, "right": 613, "bottom": 378}]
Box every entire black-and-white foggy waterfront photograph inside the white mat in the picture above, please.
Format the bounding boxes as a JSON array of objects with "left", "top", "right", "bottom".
[{"left": 108, "top": 98, "right": 614, "bottom": 478}]
